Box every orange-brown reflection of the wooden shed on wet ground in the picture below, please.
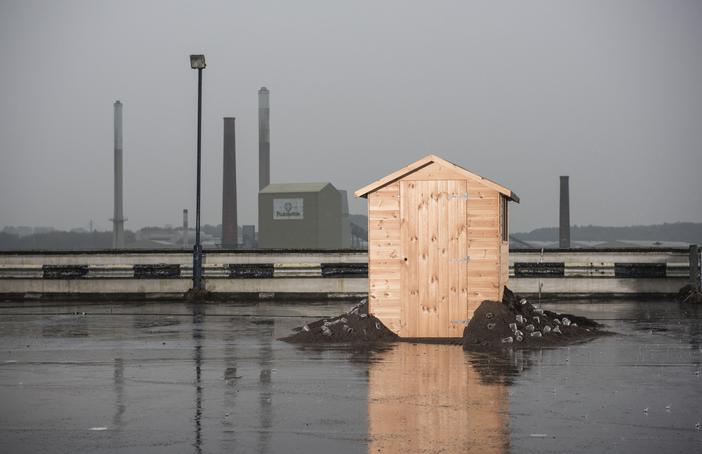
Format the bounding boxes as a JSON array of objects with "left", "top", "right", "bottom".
[{"left": 368, "top": 343, "right": 509, "bottom": 453}]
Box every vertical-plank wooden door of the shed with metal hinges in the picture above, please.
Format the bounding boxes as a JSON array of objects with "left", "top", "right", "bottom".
[{"left": 400, "top": 180, "right": 468, "bottom": 337}]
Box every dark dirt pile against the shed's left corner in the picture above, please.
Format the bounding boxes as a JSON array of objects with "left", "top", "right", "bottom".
[{"left": 280, "top": 300, "right": 399, "bottom": 344}]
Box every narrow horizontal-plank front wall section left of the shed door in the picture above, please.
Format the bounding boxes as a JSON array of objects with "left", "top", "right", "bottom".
[{"left": 368, "top": 182, "right": 402, "bottom": 334}]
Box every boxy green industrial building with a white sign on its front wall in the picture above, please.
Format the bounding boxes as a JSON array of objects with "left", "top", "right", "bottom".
[{"left": 258, "top": 183, "right": 351, "bottom": 249}]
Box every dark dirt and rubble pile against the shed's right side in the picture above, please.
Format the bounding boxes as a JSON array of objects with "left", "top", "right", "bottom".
[{"left": 463, "top": 288, "right": 603, "bottom": 351}]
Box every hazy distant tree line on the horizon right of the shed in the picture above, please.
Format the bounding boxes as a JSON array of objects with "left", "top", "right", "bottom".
[{"left": 513, "top": 222, "right": 702, "bottom": 244}]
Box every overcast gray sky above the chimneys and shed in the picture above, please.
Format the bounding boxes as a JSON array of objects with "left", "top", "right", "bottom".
[{"left": 0, "top": 0, "right": 702, "bottom": 231}]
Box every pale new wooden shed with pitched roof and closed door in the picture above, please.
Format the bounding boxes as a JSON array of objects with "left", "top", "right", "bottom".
[{"left": 355, "top": 155, "right": 519, "bottom": 337}]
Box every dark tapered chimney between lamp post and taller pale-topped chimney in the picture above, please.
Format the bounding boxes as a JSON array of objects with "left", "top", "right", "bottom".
[{"left": 222, "top": 117, "right": 238, "bottom": 249}]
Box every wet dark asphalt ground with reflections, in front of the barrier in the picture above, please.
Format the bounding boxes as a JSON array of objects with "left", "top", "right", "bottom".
[{"left": 0, "top": 301, "right": 702, "bottom": 454}]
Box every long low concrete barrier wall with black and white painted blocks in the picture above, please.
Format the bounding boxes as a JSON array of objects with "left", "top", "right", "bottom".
[{"left": 0, "top": 249, "right": 689, "bottom": 299}]
